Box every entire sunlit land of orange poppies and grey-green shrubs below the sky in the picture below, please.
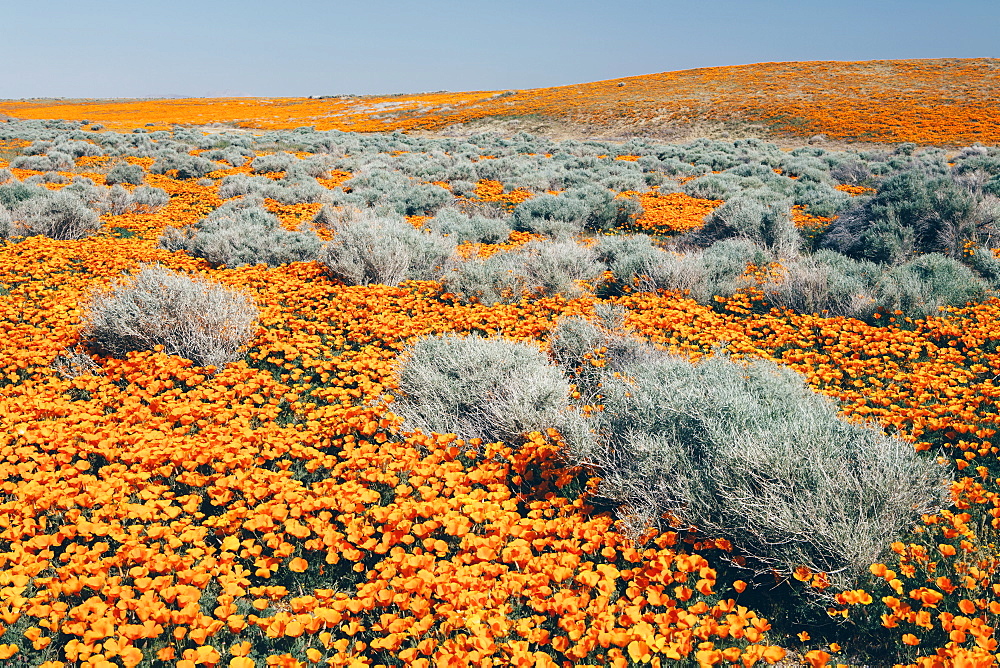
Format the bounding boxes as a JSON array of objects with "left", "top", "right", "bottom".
[{"left": 0, "top": 66, "right": 1000, "bottom": 668}]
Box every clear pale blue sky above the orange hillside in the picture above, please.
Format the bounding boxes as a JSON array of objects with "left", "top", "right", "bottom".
[{"left": 0, "top": 0, "right": 1000, "bottom": 99}]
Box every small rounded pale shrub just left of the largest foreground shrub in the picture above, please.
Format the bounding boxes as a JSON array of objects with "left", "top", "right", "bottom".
[{"left": 392, "top": 334, "right": 587, "bottom": 443}]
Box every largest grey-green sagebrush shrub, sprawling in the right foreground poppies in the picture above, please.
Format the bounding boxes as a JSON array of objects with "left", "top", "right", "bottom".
[{"left": 570, "top": 326, "right": 947, "bottom": 586}]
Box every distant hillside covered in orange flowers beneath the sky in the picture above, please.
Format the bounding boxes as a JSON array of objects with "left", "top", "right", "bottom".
[{"left": 0, "top": 58, "right": 1000, "bottom": 145}]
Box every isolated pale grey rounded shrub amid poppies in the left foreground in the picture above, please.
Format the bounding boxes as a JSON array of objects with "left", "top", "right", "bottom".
[{"left": 83, "top": 266, "right": 258, "bottom": 367}]
